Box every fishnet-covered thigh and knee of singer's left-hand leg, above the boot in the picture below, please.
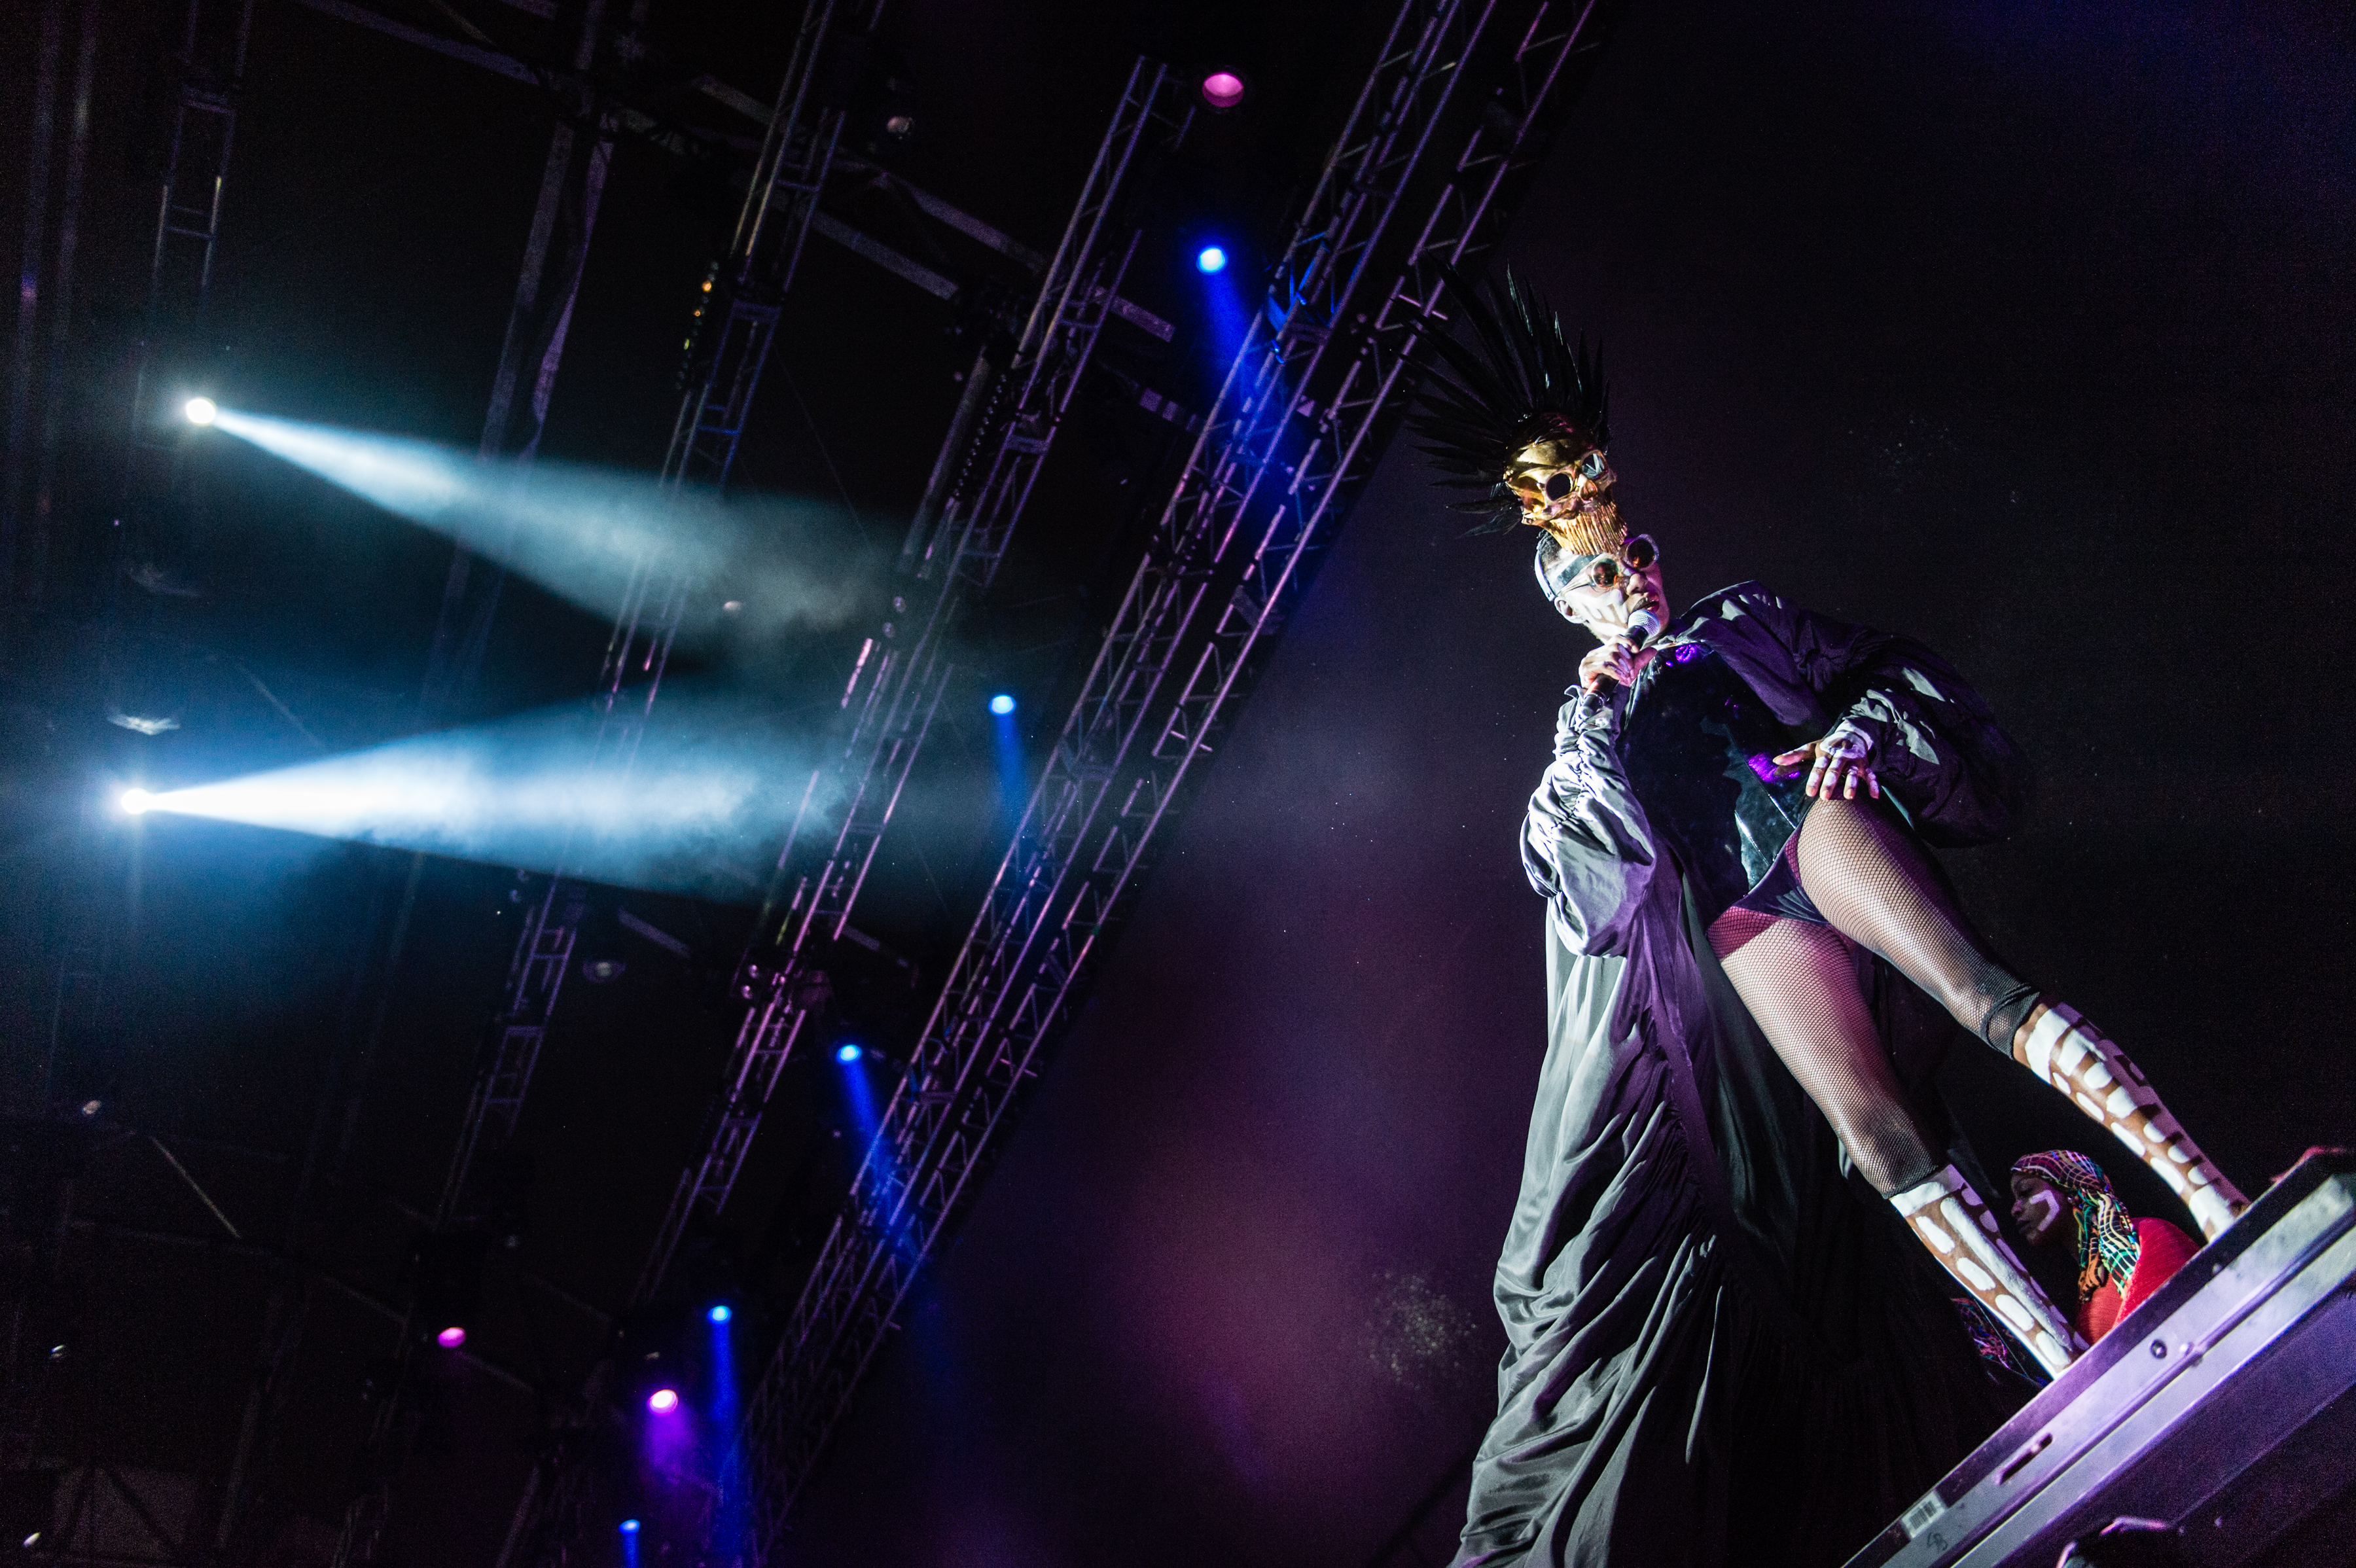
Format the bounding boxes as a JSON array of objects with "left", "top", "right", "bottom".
[{"left": 1711, "top": 918, "right": 1932, "bottom": 1194}]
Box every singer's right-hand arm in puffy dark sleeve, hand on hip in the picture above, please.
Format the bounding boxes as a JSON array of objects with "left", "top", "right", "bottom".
[{"left": 1743, "top": 591, "right": 2029, "bottom": 843}]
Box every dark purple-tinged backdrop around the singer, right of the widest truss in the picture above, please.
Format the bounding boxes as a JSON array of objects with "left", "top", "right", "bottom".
[{"left": 787, "top": 5, "right": 2356, "bottom": 1565}]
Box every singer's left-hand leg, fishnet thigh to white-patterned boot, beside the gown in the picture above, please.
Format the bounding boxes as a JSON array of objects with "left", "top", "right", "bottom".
[{"left": 1711, "top": 909, "right": 2082, "bottom": 1375}]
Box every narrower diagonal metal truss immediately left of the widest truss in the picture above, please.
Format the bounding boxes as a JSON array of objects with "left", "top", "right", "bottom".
[{"left": 634, "top": 59, "right": 1192, "bottom": 1302}]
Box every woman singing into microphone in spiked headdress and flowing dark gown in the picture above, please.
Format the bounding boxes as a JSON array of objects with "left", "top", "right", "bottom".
[{"left": 1416, "top": 278, "right": 2245, "bottom": 1563}]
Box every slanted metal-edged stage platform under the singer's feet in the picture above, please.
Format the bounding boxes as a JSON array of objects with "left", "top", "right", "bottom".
[{"left": 1847, "top": 1151, "right": 2356, "bottom": 1568}]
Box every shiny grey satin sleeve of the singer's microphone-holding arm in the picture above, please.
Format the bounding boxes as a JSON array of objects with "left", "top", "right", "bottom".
[{"left": 1522, "top": 702, "right": 1664, "bottom": 953}]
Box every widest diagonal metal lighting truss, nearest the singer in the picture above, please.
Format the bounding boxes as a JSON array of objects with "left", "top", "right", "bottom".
[{"left": 723, "top": 0, "right": 1602, "bottom": 1535}]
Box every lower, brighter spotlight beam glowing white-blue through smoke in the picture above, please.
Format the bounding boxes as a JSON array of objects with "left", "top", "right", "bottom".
[{"left": 153, "top": 687, "right": 832, "bottom": 902}]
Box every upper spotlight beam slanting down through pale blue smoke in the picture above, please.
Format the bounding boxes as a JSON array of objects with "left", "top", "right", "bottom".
[{"left": 215, "top": 410, "right": 860, "bottom": 641}]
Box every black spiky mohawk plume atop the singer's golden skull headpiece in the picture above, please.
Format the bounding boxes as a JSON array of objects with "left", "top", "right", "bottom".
[{"left": 1409, "top": 266, "right": 1611, "bottom": 535}]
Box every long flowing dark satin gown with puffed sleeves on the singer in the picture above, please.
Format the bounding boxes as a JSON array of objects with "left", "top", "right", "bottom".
[{"left": 1456, "top": 584, "right": 2033, "bottom": 1568}]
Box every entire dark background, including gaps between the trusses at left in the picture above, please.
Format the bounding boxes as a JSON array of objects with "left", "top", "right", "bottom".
[{"left": 0, "top": 0, "right": 2356, "bottom": 1568}]
